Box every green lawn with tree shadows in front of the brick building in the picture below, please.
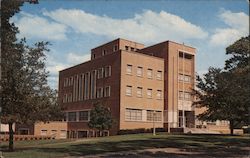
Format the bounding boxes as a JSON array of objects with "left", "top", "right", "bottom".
[{"left": 1, "top": 134, "right": 250, "bottom": 158}]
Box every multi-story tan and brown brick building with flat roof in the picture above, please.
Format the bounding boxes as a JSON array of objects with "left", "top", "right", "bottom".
[{"left": 59, "top": 39, "right": 195, "bottom": 137}]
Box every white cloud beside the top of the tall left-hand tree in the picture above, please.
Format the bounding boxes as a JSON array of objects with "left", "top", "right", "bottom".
[{"left": 12, "top": 12, "right": 67, "bottom": 40}]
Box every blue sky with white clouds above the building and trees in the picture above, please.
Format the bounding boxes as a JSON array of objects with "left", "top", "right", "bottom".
[{"left": 11, "top": 0, "right": 249, "bottom": 88}]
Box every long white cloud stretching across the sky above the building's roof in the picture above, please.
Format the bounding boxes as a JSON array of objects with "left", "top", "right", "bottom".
[{"left": 43, "top": 9, "right": 207, "bottom": 43}]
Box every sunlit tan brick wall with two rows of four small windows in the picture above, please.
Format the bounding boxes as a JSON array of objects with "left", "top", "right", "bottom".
[{"left": 120, "top": 51, "right": 164, "bottom": 129}]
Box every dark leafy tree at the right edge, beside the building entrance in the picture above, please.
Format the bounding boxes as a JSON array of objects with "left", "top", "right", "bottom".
[{"left": 194, "top": 36, "right": 250, "bottom": 134}]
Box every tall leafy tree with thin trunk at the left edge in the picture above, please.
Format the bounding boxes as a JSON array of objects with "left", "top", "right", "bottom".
[{"left": 0, "top": 0, "right": 62, "bottom": 151}]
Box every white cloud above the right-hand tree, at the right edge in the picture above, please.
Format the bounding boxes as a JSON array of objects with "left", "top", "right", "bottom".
[{"left": 210, "top": 10, "right": 249, "bottom": 46}]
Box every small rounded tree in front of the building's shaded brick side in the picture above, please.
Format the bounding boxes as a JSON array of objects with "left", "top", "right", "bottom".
[{"left": 88, "top": 103, "right": 114, "bottom": 135}]
